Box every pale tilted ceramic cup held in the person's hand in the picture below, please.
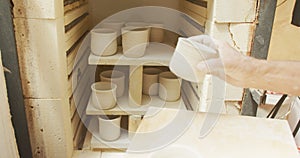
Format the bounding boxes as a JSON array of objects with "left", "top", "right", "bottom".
[{"left": 170, "top": 38, "right": 218, "bottom": 82}]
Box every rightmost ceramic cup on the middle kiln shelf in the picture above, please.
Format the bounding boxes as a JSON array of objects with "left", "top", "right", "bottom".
[{"left": 159, "top": 71, "right": 181, "bottom": 102}]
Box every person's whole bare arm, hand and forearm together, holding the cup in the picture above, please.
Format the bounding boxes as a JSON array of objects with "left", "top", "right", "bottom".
[{"left": 192, "top": 36, "right": 300, "bottom": 96}]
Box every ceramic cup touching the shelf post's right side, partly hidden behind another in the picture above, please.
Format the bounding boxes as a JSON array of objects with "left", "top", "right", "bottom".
[{"left": 143, "top": 68, "right": 162, "bottom": 95}]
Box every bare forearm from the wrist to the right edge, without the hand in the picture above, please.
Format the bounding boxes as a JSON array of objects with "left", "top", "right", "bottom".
[{"left": 245, "top": 58, "right": 300, "bottom": 96}]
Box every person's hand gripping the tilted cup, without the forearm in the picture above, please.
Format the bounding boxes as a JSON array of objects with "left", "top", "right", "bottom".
[{"left": 189, "top": 35, "right": 253, "bottom": 87}]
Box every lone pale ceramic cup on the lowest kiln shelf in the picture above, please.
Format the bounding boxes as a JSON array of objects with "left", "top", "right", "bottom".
[{"left": 98, "top": 116, "right": 121, "bottom": 141}]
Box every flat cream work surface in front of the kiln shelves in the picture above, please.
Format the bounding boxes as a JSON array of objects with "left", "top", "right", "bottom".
[{"left": 126, "top": 108, "right": 299, "bottom": 158}]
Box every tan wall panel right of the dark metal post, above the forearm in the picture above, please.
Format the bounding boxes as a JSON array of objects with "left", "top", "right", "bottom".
[{"left": 268, "top": 0, "right": 300, "bottom": 61}]
